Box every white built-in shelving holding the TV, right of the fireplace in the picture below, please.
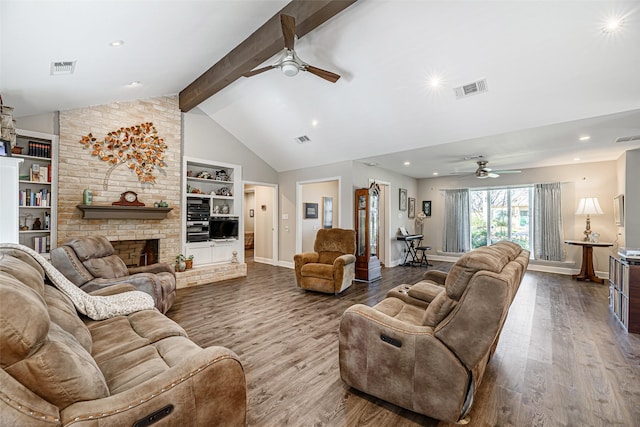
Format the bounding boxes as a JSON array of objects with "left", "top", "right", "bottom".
[{"left": 182, "top": 157, "right": 244, "bottom": 266}]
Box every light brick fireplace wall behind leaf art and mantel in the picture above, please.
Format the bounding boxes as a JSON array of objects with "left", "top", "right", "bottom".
[{"left": 58, "top": 96, "right": 182, "bottom": 264}]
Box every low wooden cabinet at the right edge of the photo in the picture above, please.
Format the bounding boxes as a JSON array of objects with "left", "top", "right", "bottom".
[{"left": 609, "top": 256, "right": 640, "bottom": 334}]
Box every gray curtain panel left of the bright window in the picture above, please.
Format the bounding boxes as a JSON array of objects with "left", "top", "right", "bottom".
[{"left": 443, "top": 188, "right": 471, "bottom": 252}]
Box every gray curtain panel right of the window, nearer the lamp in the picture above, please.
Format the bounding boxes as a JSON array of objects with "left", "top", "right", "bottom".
[{"left": 533, "top": 182, "right": 564, "bottom": 261}]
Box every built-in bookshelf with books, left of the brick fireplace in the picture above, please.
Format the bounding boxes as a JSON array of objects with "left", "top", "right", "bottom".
[{"left": 13, "top": 129, "right": 58, "bottom": 255}]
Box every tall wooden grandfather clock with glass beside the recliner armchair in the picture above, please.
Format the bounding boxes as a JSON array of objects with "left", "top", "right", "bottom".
[{"left": 355, "top": 182, "right": 382, "bottom": 282}]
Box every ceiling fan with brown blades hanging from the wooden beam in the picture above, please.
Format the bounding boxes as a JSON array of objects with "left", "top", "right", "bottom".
[{"left": 243, "top": 15, "right": 340, "bottom": 83}]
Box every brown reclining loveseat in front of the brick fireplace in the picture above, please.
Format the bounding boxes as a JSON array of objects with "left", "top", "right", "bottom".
[{"left": 51, "top": 236, "right": 176, "bottom": 313}]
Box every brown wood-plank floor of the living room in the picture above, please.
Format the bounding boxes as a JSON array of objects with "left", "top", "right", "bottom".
[{"left": 167, "top": 262, "right": 640, "bottom": 427}]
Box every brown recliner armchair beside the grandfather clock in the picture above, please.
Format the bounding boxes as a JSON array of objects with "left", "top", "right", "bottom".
[{"left": 293, "top": 228, "right": 356, "bottom": 294}]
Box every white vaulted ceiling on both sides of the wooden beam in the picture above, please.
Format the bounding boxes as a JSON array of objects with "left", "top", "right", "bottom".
[{"left": 0, "top": 0, "right": 640, "bottom": 178}]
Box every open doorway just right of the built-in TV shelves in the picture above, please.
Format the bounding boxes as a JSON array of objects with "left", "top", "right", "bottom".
[{"left": 243, "top": 181, "right": 278, "bottom": 265}]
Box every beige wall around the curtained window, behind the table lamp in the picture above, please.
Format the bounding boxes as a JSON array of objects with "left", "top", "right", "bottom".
[{"left": 419, "top": 161, "right": 618, "bottom": 271}]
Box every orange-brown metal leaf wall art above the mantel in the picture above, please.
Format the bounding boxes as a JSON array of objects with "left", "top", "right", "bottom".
[{"left": 80, "top": 122, "right": 167, "bottom": 190}]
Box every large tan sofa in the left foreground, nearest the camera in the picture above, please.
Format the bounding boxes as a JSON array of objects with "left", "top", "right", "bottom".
[{"left": 0, "top": 249, "right": 246, "bottom": 427}]
